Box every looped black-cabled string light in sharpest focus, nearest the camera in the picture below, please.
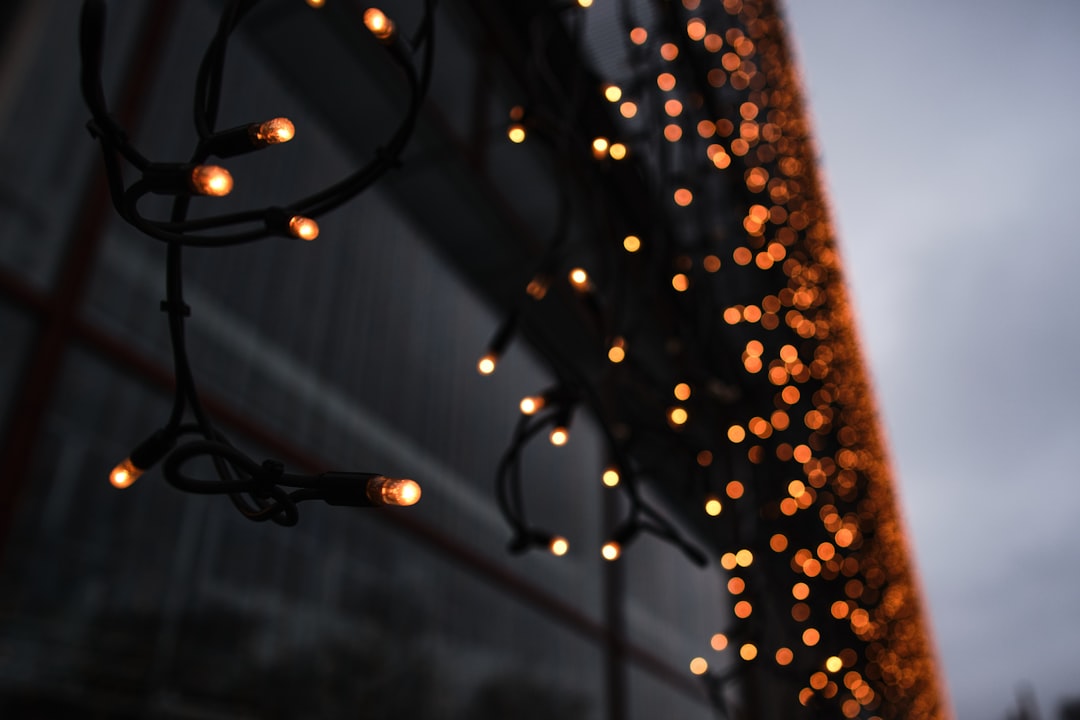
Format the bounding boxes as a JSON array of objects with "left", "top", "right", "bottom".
[{"left": 80, "top": 0, "right": 435, "bottom": 526}]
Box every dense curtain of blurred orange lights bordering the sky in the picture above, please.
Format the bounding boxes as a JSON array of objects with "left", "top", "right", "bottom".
[{"left": 481, "top": 0, "right": 947, "bottom": 720}]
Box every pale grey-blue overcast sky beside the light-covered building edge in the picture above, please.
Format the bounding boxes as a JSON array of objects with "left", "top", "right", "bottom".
[{"left": 784, "top": 0, "right": 1080, "bottom": 720}]
